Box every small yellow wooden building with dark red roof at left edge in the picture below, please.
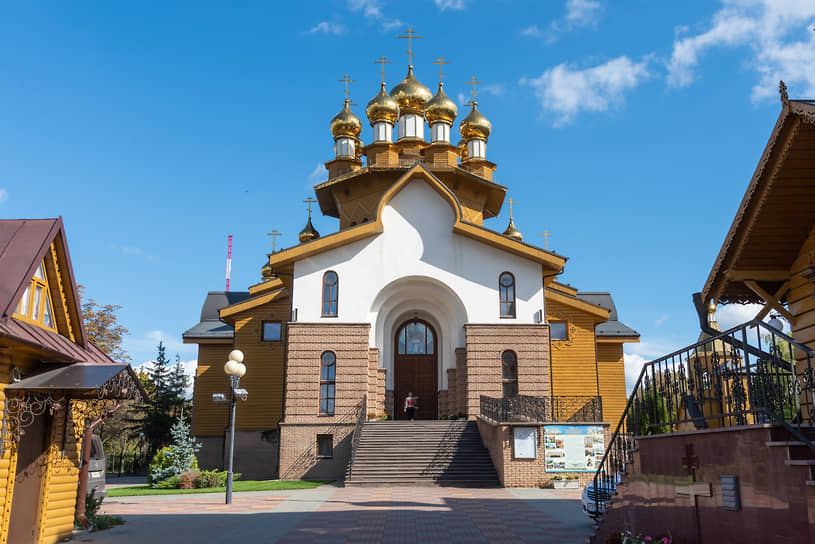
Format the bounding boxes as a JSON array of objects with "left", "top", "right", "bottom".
[{"left": 0, "top": 218, "right": 142, "bottom": 544}]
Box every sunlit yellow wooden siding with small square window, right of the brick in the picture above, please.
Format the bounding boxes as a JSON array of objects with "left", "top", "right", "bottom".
[{"left": 546, "top": 300, "right": 604, "bottom": 396}]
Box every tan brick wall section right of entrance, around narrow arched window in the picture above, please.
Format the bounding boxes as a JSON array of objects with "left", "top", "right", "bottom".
[{"left": 456, "top": 325, "right": 549, "bottom": 419}]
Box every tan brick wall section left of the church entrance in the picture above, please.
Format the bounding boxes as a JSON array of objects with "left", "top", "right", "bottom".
[{"left": 280, "top": 323, "right": 370, "bottom": 479}]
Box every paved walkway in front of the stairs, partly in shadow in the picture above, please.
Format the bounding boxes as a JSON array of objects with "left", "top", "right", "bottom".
[{"left": 75, "top": 485, "right": 592, "bottom": 544}]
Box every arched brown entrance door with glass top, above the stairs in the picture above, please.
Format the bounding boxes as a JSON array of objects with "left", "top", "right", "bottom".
[{"left": 393, "top": 319, "right": 439, "bottom": 419}]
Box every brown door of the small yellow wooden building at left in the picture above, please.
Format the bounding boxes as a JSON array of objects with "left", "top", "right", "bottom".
[{"left": 8, "top": 413, "right": 50, "bottom": 544}]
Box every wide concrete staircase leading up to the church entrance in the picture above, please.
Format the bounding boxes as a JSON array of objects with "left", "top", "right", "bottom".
[{"left": 345, "top": 421, "right": 498, "bottom": 487}]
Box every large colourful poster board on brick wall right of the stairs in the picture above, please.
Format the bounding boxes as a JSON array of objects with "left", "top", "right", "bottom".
[{"left": 543, "top": 425, "right": 606, "bottom": 472}]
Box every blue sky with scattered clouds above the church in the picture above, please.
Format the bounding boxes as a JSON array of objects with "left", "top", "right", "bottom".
[{"left": 0, "top": 0, "right": 815, "bottom": 384}]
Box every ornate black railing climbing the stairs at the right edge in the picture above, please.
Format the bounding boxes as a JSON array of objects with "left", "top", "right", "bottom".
[{"left": 593, "top": 319, "right": 815, "bottom": 517}]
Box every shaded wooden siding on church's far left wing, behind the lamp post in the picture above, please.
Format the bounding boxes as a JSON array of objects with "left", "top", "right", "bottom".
[{"left": 192, "top": 343, "right": 236, "bottom": 436}]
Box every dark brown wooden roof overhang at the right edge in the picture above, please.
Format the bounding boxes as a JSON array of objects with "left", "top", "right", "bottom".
[{"left": 702, "top": 100, "right": 815, "bottom": 303}]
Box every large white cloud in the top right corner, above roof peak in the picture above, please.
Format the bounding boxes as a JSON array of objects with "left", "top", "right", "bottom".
[{"left": 668, "top": 0, "right": 815, "bottom": 101}]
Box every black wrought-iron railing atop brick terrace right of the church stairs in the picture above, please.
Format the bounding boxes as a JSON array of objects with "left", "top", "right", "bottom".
[{"left": 481, "top": 395, "right": 603, "bottom": 423}]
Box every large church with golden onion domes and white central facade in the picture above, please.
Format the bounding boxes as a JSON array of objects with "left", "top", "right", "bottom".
[{"left": 183, "top": 47, "right": 639, "bottom": 485}]
